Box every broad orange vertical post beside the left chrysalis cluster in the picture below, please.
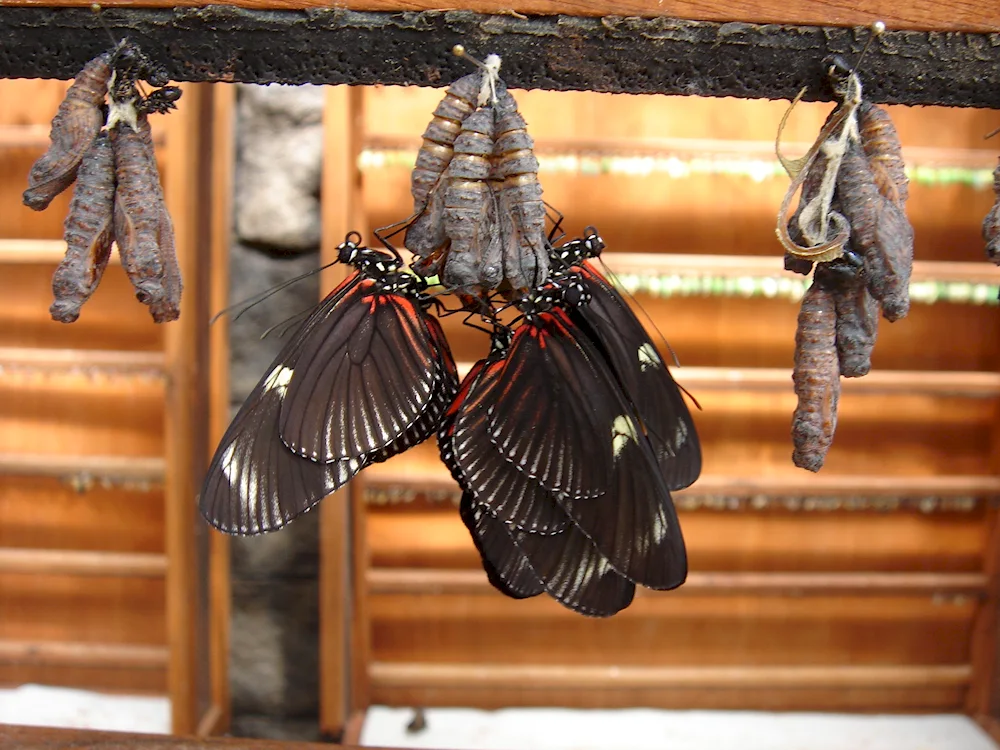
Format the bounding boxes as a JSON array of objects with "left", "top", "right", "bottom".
[{"left": 161, "top": 85, "right": 209, "bottom": 734}]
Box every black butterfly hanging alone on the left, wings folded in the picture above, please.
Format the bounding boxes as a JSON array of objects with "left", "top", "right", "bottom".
[{"left": 200, "top": 233, "right": 458, "bottom": 534}]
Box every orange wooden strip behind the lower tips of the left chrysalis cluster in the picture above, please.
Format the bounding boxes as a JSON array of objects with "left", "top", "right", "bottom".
[{"left": 0, "top": 265, "right": 163, "bottom": 351}]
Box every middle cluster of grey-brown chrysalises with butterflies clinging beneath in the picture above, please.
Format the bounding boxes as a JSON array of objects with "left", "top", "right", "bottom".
[{"left": 404, "top": 47, "right": 549, "bottom": 299}]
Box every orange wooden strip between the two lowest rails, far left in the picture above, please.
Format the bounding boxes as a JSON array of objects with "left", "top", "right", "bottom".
[{"left": 0, "top": 573, "right": 167, "bottom": 645}]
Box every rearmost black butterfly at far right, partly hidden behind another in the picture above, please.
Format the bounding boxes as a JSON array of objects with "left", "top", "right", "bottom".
[{"left": 553, "top": 228, "right": 701, "bottom": 490}]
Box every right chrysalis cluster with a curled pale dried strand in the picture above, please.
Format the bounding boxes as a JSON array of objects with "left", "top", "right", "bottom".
[{"left": 777, "top": 58, "right": 913, "bottom": 471}]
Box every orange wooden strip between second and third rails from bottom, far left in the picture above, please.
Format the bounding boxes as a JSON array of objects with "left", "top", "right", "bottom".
[{"left": 0, "top": 476, "right": 163, "bottom": 552}]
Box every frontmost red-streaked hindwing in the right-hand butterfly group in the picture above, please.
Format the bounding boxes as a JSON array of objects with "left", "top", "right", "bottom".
[{"left": 488, "top": 314, "right": 617, "bottom": 497}]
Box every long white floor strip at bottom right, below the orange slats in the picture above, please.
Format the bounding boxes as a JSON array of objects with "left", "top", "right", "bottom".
[{"left": 361, "top": 706, "right": 997, "bottom": 750}]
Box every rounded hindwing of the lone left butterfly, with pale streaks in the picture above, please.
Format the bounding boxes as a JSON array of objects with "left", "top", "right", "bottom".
[{"left": 279, "top": 279, "right": 442, "bottom": 461}]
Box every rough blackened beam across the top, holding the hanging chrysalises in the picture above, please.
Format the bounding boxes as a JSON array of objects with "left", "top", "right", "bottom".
[{"left": 0, "top": 9, "right": 1000, "bottom": 108}]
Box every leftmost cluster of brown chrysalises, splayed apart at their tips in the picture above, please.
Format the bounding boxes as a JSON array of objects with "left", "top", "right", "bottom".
[{"left": 23, "top": 41, "right": 182, "bottom": 323}]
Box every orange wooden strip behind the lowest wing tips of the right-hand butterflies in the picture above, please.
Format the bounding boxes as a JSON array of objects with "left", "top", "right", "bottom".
[{"left": 366, "top": 505, "right": 986, "bottom": 572}]
